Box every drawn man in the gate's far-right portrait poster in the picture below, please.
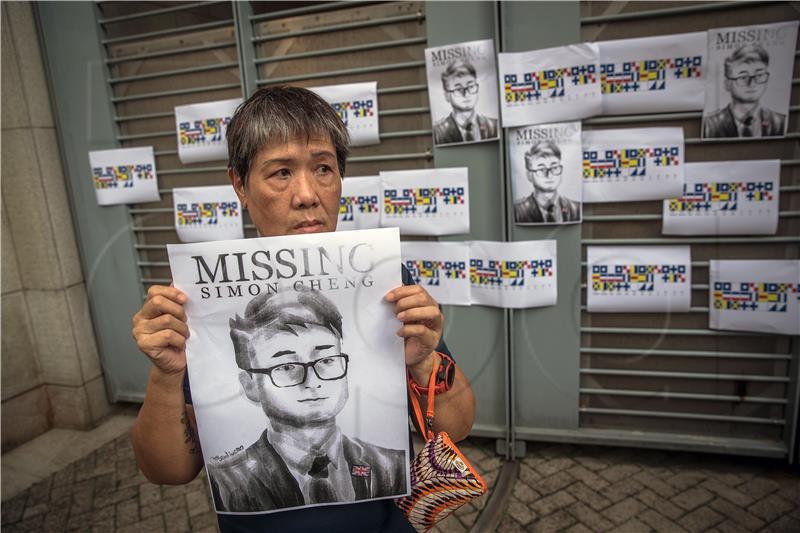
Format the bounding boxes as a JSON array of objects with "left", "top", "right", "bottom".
[{"left": 703, "top": 43, "right": 786, "bottom": 139}]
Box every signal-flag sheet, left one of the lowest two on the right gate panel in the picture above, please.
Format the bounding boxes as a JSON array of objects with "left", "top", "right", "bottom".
[{"left": 586, "top": 246, "right": 692, "bottom": 313}]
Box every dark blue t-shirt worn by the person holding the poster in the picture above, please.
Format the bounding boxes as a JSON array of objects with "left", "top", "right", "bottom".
[{"left": 183, "top": 266, "right": 452, "bottom": 533}]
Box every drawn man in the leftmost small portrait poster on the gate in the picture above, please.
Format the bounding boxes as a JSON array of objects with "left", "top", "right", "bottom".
[{"left": 433, "top": 59, "right": 497, "bottom": 145}]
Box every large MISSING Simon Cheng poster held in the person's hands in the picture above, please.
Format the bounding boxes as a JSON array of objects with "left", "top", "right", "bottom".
[{"left": 167, "top": 229, "right": 411, "bottom": 514}]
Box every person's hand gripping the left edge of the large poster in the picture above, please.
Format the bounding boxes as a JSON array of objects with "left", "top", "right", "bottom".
[{"left": 133, "top": 285, "right": 189, "bottom": 374}]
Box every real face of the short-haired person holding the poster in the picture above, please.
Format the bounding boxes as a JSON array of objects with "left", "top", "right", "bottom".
[{"left": 228, "top": 138, "right": 342, "bottom": 237}]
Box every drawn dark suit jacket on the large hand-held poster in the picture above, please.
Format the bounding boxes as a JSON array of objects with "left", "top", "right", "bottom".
[{"left": 208, "top": 431, "right": 406, "bottom": 513}]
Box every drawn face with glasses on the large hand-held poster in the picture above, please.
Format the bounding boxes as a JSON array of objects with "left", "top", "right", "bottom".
[{"left": 239, "top": 325, "right": 348, "bottom": 427}]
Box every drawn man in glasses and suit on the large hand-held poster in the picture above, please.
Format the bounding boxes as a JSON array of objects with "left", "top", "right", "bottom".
[{"left": 208, "top": 290, "right": 406, "bottom": 512}]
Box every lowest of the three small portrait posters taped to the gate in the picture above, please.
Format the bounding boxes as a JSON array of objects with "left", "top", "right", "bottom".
[{"left": 507, "top": 122, "right": 583, "bottom": 225}]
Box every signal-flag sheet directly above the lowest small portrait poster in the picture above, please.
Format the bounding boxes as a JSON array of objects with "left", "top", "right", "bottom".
[{"left": 497, "top": 43, "right": 602, "bottom": 128}]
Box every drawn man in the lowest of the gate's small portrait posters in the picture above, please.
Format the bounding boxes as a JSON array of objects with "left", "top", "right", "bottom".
[{"left": 514, "top": 140, "right": 581, "bottom": 224}]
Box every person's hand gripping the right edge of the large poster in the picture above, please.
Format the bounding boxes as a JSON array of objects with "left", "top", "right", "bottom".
[{"left": 386, "top": 285, "right": 444, "bottom": 379}]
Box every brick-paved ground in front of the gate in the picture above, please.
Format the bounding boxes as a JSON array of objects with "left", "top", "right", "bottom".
[{"left": 2, "top": 435, "right": 800, "bottom": 533}]
